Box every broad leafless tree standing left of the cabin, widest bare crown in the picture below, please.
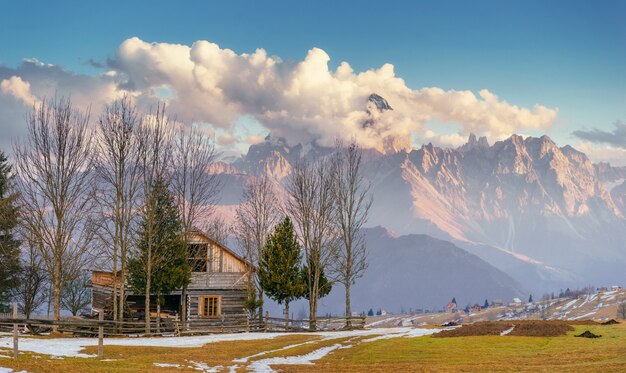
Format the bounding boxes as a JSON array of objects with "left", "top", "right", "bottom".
[{"left": 14, "top": 99, "right": 94, "bottom": 320}]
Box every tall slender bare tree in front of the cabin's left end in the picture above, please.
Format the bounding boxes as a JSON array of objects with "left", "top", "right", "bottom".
[{"left": 96, "top": 96, "right": 143, "bottom": 320}]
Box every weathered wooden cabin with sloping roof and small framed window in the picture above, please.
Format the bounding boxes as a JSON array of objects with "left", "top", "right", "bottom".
[{"left": 92, "top": 230, "right": 254, "bottom": 322}]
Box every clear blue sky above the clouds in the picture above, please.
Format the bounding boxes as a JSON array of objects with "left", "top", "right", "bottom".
[{"left": 0, "top": 1, "right": 626, "bottom": 161}]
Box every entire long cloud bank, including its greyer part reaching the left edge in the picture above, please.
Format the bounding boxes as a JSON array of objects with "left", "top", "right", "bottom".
[{"left": 0, "top": 38, "right": 558, "bottom": 150}]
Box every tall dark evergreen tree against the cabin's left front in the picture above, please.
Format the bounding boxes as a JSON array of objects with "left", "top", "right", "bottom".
[{"left": 128, "top": 180, "right": 191, "bottom": 312}]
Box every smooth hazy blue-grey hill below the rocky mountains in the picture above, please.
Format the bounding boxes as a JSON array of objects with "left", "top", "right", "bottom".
[{"left": 314, "top": 227, "right": 525, "bottom": 313}]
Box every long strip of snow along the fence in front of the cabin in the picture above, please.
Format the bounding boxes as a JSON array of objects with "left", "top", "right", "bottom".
[{"left": 0, "top": 327, "right": 434, "bottom": 358}]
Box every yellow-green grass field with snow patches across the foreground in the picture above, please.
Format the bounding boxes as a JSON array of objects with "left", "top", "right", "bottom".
[{"left": 0, "top": 323, "right": 626, "bottom": 373}]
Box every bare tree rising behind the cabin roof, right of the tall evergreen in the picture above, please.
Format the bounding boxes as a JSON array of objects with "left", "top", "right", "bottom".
[{"left": 172, "top": 126, "right": 221, "bottom": 325}]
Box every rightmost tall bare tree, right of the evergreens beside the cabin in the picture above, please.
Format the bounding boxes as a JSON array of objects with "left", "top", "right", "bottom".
[{"left": 332, "top": 141, "right": 372, "bottom": 328}]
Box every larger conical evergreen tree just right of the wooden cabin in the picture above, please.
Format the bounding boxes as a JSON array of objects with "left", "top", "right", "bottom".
[{"left": 258, "top": 217, "right": 307, "bottom": 320}]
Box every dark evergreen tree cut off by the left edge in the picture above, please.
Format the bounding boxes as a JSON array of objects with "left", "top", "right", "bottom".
[{"left": 0, "top": 151, "right": 20, "bottom": 312}]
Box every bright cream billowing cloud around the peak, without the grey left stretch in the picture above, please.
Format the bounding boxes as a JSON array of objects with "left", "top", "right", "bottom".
[{"left": 112, "top": 38, "right": 558, "bottom": 149}]
